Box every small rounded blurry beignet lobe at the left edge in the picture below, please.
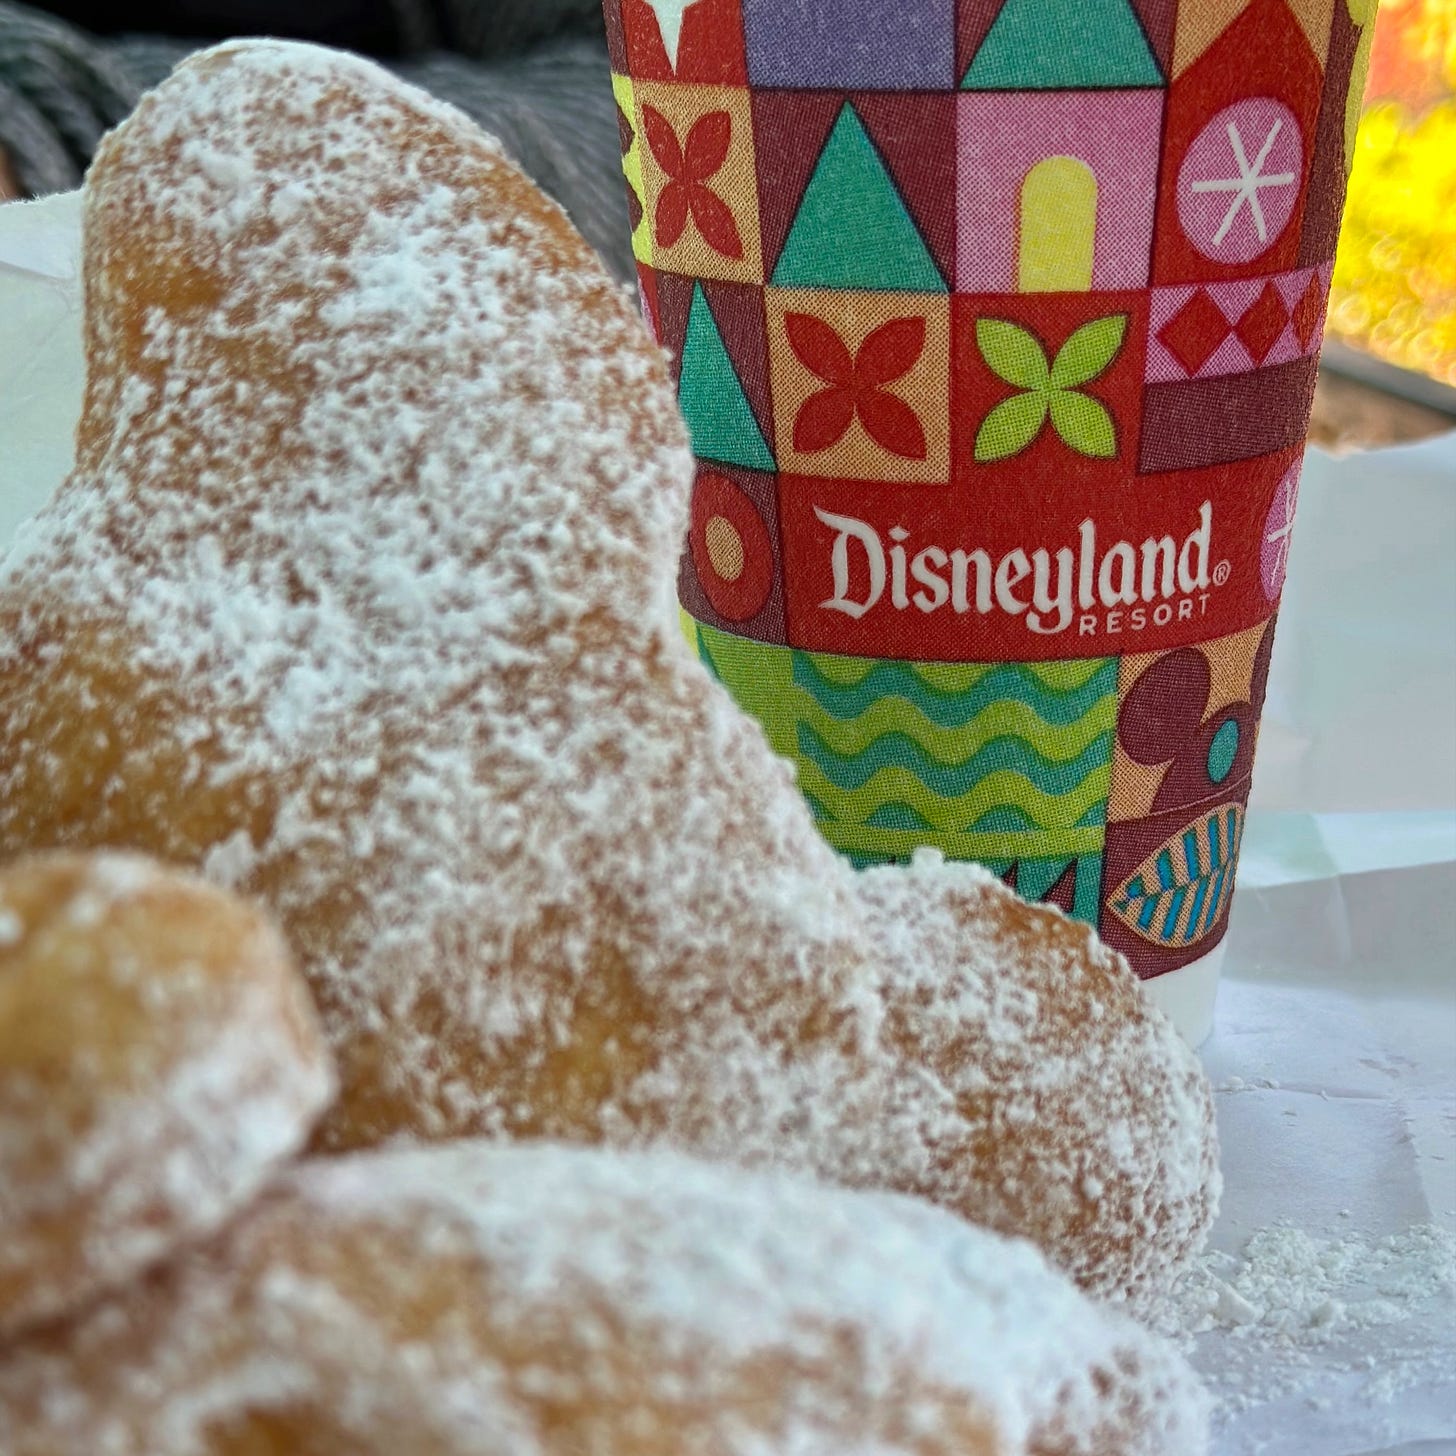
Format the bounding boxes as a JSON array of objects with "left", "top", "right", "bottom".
[{"left": 0, "top": 853, "right": 333, "bottom": 1339}]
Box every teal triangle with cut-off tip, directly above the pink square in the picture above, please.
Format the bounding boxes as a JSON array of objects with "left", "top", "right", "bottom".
[{"left": 962, "top": 0, "right": 1163, "bottom": 90}]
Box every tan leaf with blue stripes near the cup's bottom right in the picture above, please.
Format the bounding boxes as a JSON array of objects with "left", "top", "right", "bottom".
[{"left": 1108, "top": 804, "right": 1243, "bottom": 949}]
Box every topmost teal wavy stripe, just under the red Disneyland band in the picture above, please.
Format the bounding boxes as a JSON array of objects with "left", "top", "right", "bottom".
[{"left": 794, "top": 652, "right": 1117, "bottom": 728}]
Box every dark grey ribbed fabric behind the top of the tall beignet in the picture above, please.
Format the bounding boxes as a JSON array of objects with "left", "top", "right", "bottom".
[{"left": 0, "top": 0, "right": 632, "bottom": 278}]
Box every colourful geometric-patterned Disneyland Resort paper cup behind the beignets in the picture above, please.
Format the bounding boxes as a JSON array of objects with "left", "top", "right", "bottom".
[{"left": 606, "top": 0, "right": 1374, "bottom": 1041}]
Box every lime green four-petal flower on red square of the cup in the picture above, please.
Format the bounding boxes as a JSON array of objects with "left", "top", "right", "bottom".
[{"left": 976, "top": 313, "right": 1128, "bottom": 464}]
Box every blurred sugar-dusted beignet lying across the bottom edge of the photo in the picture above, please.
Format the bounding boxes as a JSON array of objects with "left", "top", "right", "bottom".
[{"left": 0, "top": 1143, "right": 1204, "bottom": 1456}]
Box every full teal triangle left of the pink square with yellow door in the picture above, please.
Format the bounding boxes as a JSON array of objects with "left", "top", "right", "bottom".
[{"left": 773, "top": 102, "right": 948, "bottom": 293}]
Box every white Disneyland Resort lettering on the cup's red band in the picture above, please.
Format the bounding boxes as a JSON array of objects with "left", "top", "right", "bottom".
[{"left": 814, "top": 501, "right": 1229, "bottom": 636}]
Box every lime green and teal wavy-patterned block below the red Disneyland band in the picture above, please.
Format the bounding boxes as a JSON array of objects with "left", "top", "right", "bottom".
[{"left": 684, "top": 619, "right": 1118, "bottom": 922}]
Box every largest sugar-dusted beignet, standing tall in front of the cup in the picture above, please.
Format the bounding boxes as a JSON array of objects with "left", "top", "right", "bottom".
[{"left": 0, "top": 42, "right": 1217, "bottom": 1294}]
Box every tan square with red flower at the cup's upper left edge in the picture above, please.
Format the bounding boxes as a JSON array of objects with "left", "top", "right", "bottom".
[{"left": 633, "top": 82, "right": 763, "bottom": 284}]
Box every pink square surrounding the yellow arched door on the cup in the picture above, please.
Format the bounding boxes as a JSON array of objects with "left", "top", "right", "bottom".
[{"left": 957, "top": 90, "right": 1163, "bottom": 293}]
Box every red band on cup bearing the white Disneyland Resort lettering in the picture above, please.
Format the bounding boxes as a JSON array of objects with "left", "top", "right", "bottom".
[{"left": 779, "top": 450, "right": 1299, "bottom": 662}]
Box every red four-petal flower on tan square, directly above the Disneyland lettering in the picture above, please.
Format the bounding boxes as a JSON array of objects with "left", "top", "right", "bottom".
[{"left": 783, "top": 313, "right": 926, "bottom": 460}]
